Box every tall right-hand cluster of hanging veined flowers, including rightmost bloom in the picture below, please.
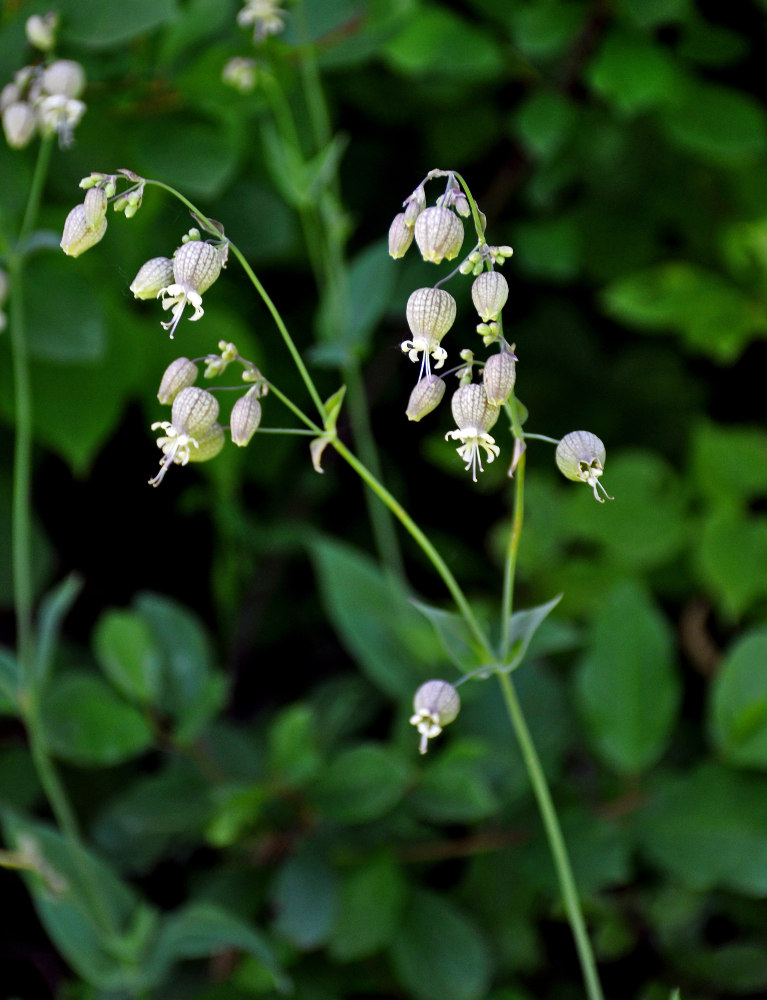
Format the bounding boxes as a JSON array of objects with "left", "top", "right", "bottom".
[{"left": 389, "top": 170, "right": 612, "bottom": 502}]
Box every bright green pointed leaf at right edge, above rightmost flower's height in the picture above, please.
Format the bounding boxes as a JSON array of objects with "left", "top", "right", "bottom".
[{"left": 602, "top": 261, "right": 765, "bottom": 361}]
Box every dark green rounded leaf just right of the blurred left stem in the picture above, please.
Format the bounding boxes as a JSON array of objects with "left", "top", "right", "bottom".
[{"left": 41, "top": 673, "right": 154, "bottom": 767}]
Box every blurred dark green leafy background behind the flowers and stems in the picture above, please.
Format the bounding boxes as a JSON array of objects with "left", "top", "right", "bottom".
[{"left": 0, "top": 0, "right": 767, "bottom": 1000}]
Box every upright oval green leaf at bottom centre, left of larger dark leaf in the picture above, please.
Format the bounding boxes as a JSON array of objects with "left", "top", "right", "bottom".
[{"left": 328, "top": 853, "right": 407, "bottom": 962}]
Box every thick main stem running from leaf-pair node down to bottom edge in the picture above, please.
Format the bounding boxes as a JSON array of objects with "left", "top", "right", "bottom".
[{"left": 497, "top": 673, "right": 602, "bottom": 1000}]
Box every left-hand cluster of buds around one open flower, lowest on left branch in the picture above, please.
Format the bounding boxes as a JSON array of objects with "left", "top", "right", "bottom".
[{"left": 149, "top": 340, "right": 269, "bottom": 486}]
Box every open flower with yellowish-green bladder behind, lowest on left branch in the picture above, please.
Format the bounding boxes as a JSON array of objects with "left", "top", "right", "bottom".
[{"left": 149, "top": 386, "right": 224, "bottom": 486}]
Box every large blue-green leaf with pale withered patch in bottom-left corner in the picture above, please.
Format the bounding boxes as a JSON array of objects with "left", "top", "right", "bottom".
[{"left": 3, "top": 812, "right": 156, "bottom": 994}]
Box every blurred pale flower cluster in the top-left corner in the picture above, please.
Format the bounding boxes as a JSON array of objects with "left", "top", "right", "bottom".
[{"left": 0, "top": 13, "right": 85, "bottom": 149}]
